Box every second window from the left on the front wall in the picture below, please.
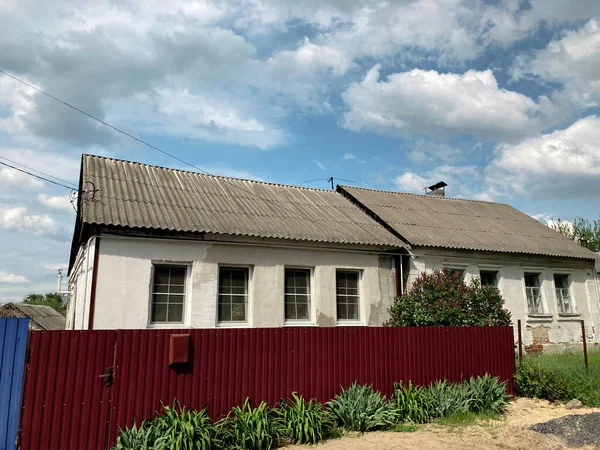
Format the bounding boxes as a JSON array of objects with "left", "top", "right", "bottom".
[{"left": 218, "top": 267, "right": 249, "bottom": 322}]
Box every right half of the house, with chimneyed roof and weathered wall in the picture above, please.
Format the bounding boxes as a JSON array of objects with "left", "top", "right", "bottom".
[{"left": 338, "top": 186, "right": 600, "bottom": 351}]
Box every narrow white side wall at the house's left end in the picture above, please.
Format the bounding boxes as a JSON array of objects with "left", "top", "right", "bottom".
[{"left": 65, "top": 237, "right": 96, "bottom": 330}]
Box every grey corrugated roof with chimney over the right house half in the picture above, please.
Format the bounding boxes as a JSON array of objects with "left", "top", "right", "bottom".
[{"left": 339, "top": 186, "right": 595, "bottom": 259}]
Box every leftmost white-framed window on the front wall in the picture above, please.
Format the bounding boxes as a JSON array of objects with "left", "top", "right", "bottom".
[{"left": 151, "top": 264, "right": 187, "bottom": 323}]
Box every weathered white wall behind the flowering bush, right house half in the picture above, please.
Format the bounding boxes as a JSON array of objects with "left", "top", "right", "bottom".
[{"left": 408, "top": 248, "right": 600, "bottom": 345}]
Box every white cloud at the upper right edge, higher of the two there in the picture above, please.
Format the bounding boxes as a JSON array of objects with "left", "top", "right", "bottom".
[{"left": 513, "top": 19, "right": 600, "bottom": 107}]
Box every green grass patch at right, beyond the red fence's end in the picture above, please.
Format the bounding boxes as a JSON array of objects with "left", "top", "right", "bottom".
[{"left": 527, "top": 351, "right": 600, "bottom": 406}]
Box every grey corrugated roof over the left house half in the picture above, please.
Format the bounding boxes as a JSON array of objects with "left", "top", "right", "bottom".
[{"left": 81, "top": 155, "right": 404, "bottom": 248}]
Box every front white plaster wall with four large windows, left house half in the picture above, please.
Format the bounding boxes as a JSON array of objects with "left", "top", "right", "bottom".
[{"left": 82, "top": 235, "right": 395, "bottom": 329}]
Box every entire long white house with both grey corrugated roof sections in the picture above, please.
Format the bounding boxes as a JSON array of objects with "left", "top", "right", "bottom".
[{"left": 67, "top": 155, "right": 600, "bottom": 350}]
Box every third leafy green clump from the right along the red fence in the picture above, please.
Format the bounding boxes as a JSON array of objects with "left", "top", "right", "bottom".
[{"left": 391, "top": 381, "right": 434, "bottom": 423}]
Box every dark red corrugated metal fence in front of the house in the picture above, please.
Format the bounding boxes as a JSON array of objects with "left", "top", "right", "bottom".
[{"left": 21, "top": 327, "right": 515, "bottom": 450}]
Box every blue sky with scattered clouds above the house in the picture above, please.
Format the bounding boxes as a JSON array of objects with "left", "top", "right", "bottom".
[{"left": 0, "top": 0, "right": 600, "bottom": 303}]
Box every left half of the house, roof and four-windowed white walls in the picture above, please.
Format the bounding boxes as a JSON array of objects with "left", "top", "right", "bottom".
[{"left": 67, "top": 155, "right": 407, "bottom": 329}]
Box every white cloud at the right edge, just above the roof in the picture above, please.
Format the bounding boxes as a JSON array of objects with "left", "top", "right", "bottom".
[{"left": 486, "top": 116, "right": 600, "bottom": 198}]
